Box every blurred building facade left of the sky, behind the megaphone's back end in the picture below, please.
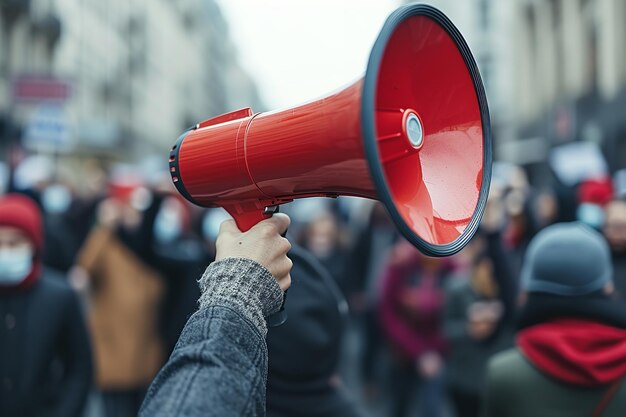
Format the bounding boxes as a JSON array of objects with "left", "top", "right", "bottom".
[{"left": 0, "top": 0, "right": 263, "bottom": 157}]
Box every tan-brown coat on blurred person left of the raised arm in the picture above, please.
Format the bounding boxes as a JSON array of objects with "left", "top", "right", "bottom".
[{"left": 78, "top": 227, "right": 164, "bottom": 389}]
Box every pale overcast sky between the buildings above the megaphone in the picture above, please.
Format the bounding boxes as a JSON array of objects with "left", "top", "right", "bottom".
[{"left": 217, "top": 0, "right": 400, "bottom": 109}]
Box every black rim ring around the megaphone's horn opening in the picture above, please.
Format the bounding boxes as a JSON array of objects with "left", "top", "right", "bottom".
[{"left": 361, "top": 4, "right": 492, "bottom": 256}]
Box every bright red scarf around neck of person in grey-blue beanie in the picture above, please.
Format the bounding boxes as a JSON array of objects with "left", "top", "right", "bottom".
[{"left": 517, "top": 319, "right": 626, "bottom": 387}]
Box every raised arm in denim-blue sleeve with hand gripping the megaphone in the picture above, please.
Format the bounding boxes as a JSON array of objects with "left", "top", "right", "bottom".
[{"left": 140, "top": 214, "right": 291, "bottom": 417}]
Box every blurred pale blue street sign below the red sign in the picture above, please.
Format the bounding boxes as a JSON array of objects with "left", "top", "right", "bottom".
[{"left": 22, "top": 103, "right": 73, "bottom": 152}]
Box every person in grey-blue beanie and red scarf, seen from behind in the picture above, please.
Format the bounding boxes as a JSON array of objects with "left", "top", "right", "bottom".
[{"left": 484, "top": 223, "right": 626, "bottom": 417}]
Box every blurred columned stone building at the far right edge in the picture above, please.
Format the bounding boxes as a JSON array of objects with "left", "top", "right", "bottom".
[{"left": 514, "top": 0, "right": 626, "bottom": 171}]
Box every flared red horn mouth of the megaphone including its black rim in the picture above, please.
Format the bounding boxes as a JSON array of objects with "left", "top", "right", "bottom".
[{"left": 361, "top": 4, "right": 492, "bottom": 256}]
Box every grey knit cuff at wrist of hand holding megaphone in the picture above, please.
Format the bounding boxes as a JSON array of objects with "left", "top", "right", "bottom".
[{"left": 198, "top": 258, "right": 284, "bottom": 337}]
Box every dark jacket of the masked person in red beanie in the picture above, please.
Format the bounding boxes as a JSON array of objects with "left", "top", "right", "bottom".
[{"left": 0, "top": 273, "right": 92, "bottom": 417}]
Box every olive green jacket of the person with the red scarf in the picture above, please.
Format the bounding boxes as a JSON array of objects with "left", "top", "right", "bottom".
[{"left": 483, "top": 349, "right": 626, "bottom": 417}]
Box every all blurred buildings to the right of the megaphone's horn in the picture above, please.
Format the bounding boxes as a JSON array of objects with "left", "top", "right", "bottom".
[{"left": 404, "top": 0, "right": 626, "bottom": 171}]
